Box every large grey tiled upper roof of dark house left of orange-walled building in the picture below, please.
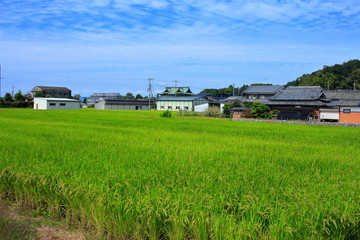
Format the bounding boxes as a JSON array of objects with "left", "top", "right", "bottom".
[{"left": 270, "top": 86, "right": 326, "bottom": 101}]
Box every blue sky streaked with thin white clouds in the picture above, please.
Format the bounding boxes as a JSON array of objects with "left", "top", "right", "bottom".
[{"left": 0, "top": 0, "right": 360, "bottom": 96}]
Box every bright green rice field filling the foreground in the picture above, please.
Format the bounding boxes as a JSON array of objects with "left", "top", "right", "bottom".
[{"left": 0, "top": 109, "right": 360, "bottom": 239}]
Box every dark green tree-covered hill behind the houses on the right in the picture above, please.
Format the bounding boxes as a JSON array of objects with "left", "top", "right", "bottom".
[{"left": 286, "top": 59, "right": 360, "bottom": 90}]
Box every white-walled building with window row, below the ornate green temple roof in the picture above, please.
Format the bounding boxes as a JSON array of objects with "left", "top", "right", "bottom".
[{"left": 157, "top": 96, "right": 209, "bottom": 111}]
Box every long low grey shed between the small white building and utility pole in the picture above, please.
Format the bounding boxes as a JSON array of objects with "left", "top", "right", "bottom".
[{"left": 95, "top": 99, "right": 154, "bottom": 110}]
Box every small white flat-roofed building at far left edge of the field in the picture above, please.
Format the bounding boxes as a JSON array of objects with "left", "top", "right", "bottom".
[{"left": 34, "top": 98, "right": 80, "bottom": 110}]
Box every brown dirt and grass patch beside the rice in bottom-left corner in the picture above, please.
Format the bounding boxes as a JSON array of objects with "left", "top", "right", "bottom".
[{"left": 0, "top": 200, "right": 87, "bottom": 240}]
